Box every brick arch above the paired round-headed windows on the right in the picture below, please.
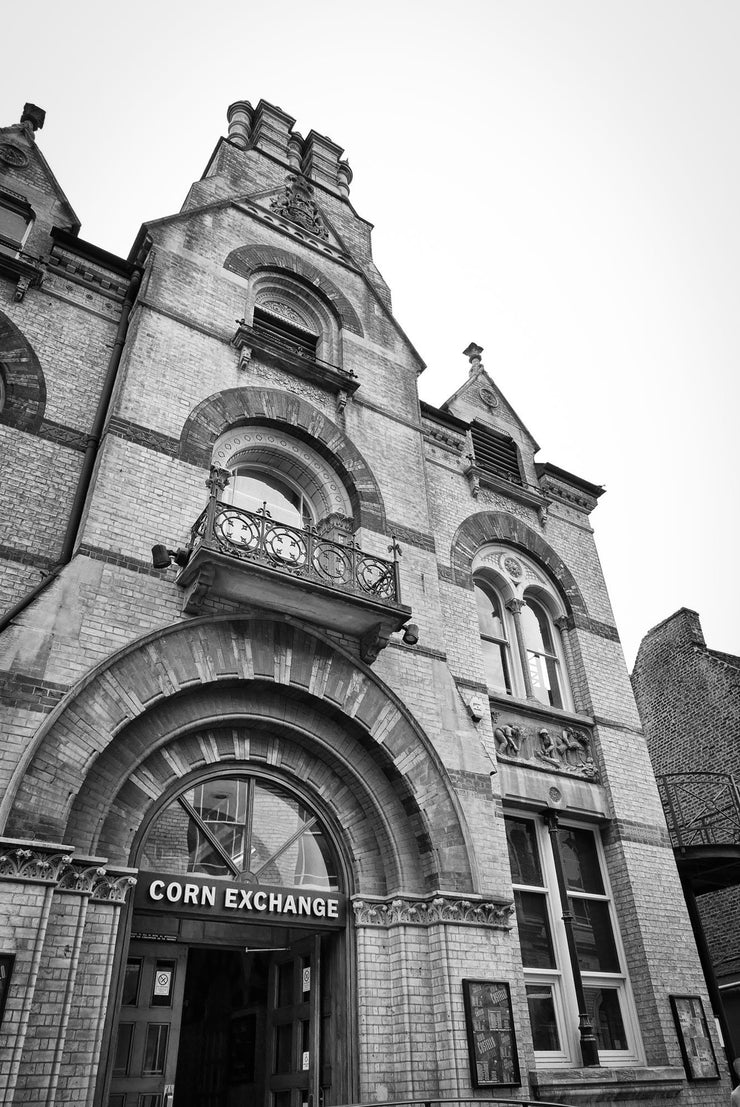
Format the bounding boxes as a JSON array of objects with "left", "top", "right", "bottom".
[{"left": 451, "top": 511, "right": 588, "bottom": 618}]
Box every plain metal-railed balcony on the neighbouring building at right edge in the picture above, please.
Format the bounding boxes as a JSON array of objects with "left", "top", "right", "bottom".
[{"left": 656, "top": 773, "right": 740, "bottom": 894}]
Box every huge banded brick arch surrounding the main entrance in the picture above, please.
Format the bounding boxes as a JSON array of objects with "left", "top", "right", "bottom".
[{"left": 3, "top": 615, "right": 477, "bottom": 891}]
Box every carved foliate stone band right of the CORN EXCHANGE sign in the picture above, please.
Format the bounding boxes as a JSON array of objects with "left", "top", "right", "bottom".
[{"left": 352, "top": 896, "right": 514, "bottom": 930}]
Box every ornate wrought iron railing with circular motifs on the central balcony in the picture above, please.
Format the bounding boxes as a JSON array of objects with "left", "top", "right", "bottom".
[{"left": 192, "top": 500, "right": 400, "bottom": 603}]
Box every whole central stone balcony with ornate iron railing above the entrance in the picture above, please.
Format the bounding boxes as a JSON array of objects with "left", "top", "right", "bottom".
[{"left": 177, "top": 470, "right": 411, "bottom": 663}]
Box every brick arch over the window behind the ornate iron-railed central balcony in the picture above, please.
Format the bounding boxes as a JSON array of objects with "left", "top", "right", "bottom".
[{"left": 179, "top": 389, "right": 386, "bottom": 531}]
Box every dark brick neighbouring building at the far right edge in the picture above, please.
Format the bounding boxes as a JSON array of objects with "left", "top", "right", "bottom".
[{"left": 633, "top": 608, "right": 740, "bottom": 1076}]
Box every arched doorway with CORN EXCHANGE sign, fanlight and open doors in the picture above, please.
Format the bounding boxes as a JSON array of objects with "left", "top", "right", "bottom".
[{"left": 104, "top": 765, "right": 347, "bottom": 1107}]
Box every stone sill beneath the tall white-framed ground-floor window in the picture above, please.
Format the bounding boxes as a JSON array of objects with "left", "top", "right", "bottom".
[{"left": 530, "top": 1065, "right": 686, "bottom": 1105}]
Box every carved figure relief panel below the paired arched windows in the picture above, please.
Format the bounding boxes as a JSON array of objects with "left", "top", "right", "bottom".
[{"left": 493, "top": 717, "right": 598, "bottom": 782}]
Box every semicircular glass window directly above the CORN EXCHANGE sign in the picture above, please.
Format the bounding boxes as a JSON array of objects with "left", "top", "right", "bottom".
[{"left": 138, "top": 775, "right": 339, "bottom": 889}]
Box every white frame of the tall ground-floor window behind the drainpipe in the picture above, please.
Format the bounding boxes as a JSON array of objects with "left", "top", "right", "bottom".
[{"left": 505, "top": 810, "right": 644, "bottom": 1068}]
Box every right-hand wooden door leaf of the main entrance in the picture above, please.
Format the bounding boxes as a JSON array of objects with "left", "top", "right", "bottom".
[{"left": 265, "top": 935, "right": 321, "bottom": 1107}]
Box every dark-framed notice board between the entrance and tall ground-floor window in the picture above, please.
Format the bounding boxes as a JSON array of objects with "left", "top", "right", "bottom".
[{"left": 463, "top": 980, "right": 521, "bottom": 1088}]
